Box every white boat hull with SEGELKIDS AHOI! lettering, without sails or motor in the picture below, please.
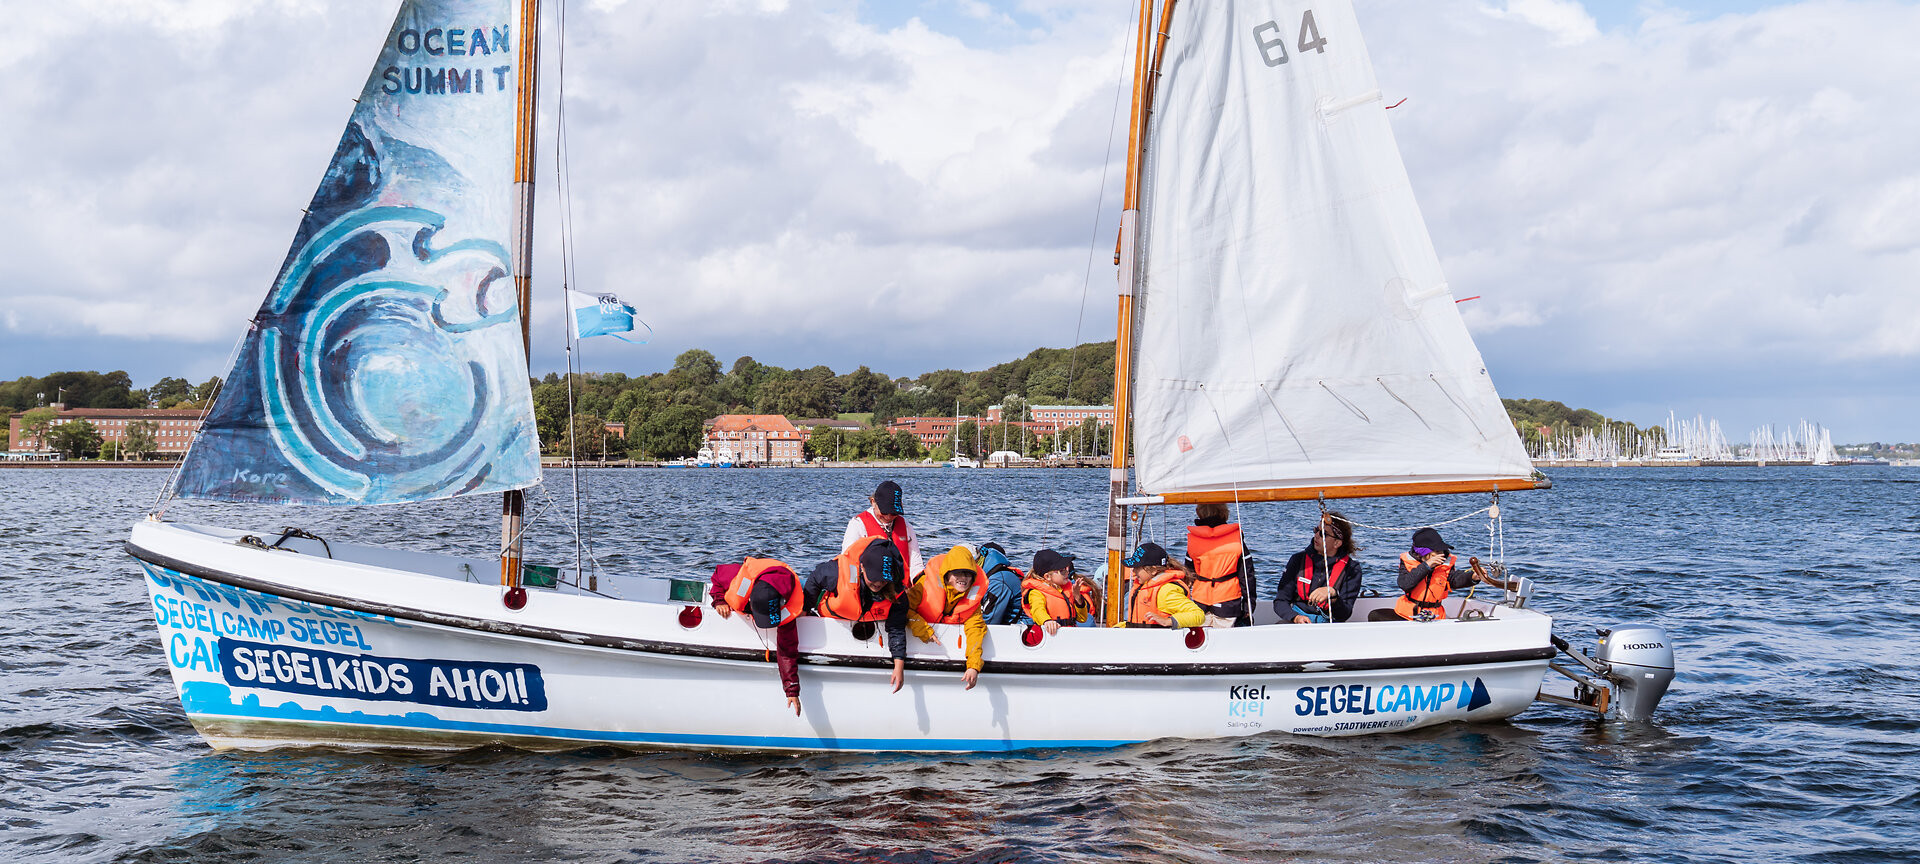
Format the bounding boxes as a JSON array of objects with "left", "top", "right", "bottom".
[{"left": 129, "top": 522, "right": 1553, "bottom": 751}]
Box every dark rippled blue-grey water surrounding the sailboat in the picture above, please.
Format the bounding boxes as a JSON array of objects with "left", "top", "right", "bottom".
[{"left": 0, "top": 468, "right": 1920, "bottom": 862}]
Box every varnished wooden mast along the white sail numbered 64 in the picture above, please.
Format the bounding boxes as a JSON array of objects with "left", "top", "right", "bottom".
[{"left": 1106, "top": 0, "right": 1173, "bottom": 626}]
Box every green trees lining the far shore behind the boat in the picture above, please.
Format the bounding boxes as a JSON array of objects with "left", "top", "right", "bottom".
[{"left": 0, "top": 342, "right": 1659, "bottom": 461}]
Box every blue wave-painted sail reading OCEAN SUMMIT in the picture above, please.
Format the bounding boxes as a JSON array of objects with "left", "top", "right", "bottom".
[{"left": 175, "top": 0, "right": 540, "bottom": 503}]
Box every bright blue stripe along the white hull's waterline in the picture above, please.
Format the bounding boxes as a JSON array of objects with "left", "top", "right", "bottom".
[{"left": 180, "top": 682, "right": 1139, "bottom": 751}]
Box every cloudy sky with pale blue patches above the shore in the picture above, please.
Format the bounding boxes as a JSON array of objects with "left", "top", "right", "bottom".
[{"left": 0, "top": 0, "right": 1920, "bottom": 442}]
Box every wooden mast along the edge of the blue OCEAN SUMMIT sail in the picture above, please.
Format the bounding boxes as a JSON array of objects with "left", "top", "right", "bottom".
[{"left": 499, "top": 0, "right": 540, "bottom": 588}]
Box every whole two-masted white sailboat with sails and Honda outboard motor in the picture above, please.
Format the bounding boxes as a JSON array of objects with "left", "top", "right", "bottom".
[{"left": 127, "top": 0, "right": 1672, "bottom": 751}]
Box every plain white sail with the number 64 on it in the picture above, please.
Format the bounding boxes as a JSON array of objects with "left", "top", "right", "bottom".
[{"left": 1133, "top": 0, "right": 1532, "bottom": 493}]
